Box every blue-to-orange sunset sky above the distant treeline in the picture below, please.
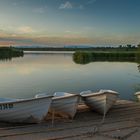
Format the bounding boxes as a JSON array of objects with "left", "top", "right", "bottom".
[{"left": 0, "top": 0, "right": 140, "bottom": 47}]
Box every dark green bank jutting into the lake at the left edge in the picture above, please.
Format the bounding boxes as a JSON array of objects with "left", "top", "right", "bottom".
[{"left": 0, "top": 47, "right": 24, "bottom": 60}]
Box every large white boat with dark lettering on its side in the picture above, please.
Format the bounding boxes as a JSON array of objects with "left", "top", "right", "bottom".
[{"left": 0, "top": 96, "right": 52, "bottom": 123}]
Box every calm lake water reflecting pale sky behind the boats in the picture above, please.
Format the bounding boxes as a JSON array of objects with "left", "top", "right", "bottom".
[{"left": 0, "top": 53, "right": 140, "bottom": 100}]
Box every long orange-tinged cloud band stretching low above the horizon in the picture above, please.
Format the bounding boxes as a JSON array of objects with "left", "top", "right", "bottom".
[{"left": 0, "top": 30, "right": 139, "bottom": 46}]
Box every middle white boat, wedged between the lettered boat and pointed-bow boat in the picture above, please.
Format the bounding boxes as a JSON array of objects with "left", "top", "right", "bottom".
[{"left": 51, "top": 92, "right": 79, "bottom": 118}]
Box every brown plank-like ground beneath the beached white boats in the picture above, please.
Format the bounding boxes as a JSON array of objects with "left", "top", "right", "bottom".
[{"left": 0, "top": 100, "right": 140, "bottom": 140}]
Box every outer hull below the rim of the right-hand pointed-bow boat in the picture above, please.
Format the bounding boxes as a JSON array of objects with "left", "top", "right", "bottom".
[{"left": 83, "top": 93, "right": 118, "bottom": 115}]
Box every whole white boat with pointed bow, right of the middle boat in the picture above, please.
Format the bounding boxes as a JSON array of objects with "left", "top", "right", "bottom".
[{"left": 80, "top": 90, "right": 119, "bottom": 115}]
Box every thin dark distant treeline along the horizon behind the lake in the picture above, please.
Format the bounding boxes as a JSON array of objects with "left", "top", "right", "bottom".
[{"left": 19, "top": 44, "right": 140, "bottom": 51}]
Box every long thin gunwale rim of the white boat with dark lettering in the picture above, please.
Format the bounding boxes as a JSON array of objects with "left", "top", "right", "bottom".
[{"left": 0, "top": 95, "right": 53, "bottom": 105}]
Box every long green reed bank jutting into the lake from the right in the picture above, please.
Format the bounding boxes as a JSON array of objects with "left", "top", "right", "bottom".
[{"left": 73, "top": 51, "right": 140, "bottom": 64}]
